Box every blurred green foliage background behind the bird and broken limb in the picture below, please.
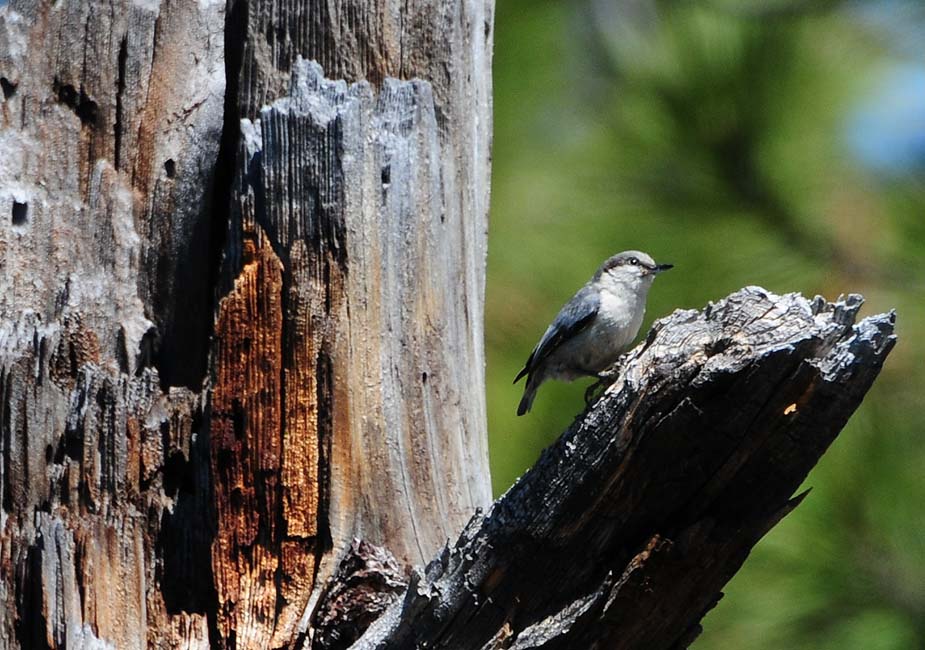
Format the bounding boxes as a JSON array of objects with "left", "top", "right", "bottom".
[{"left": 486, "top": 0, "right": 925, "bottom": 650}]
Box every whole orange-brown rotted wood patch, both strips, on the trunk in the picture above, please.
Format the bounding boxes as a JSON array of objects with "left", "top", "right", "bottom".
[{"left": 211, "top": 225, "right": 343, "bottom": 648}]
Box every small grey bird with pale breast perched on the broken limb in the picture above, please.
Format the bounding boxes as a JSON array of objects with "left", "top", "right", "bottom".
[{"left": 514, "top": 251, "right": 673, "bottom": 415}]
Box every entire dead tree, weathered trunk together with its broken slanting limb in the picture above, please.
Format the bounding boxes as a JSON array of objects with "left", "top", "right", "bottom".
[{"left": 0, "top": 0, "right": 892, "bottom": 649}]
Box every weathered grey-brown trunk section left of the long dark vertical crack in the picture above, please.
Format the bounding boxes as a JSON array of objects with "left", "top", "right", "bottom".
[{"left": 0, "top": 0, "right": 225, "bottom": 649}]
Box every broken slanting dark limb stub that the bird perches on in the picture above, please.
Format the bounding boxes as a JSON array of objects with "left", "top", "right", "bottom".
[{"left": 352, "top": 287, "right": 895, "bottom": 650}]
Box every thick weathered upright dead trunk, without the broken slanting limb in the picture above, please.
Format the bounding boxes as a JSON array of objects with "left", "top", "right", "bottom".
[{"left": 0, "top": 0, "right": 492, "bottom": 649}]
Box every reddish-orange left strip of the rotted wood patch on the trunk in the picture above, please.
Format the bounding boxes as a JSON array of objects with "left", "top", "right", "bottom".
[{"left": 211, "top": 230, "right": 294, "bottom": 640}]
